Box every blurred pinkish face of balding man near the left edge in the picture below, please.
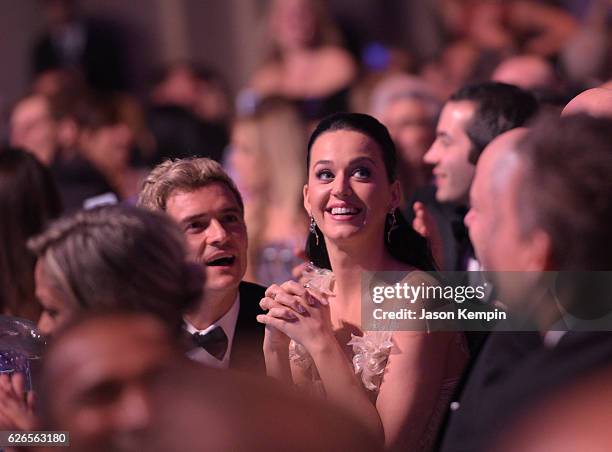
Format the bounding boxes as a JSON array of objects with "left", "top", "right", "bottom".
[{"left": 10, "top": 96, "right": 57, "bottom": 165}]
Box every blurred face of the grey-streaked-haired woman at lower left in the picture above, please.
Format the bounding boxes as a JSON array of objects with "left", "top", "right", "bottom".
[{"left": 34, "top": 259, "right": 74, "bottom": 336}]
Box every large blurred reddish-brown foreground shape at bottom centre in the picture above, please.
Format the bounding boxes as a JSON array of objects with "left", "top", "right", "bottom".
[{"left": 143, "top": 354, "right": 381, "bottom": 452}]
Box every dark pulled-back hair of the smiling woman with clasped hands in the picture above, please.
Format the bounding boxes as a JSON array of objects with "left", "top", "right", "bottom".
[{"left": 306, "top": 113, "right": 435, "bottom": 270}]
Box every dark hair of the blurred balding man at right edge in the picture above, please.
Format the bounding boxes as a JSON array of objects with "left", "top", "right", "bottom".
[{"left": 517, "top": 114, "right": 612, "bottom": 271}]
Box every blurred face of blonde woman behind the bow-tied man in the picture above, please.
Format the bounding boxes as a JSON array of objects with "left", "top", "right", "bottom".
[{"left": 230, "top": 122, "right": 267, "bottom": 193}]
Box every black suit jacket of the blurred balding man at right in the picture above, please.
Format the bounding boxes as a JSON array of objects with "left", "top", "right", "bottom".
[{"left": 441, "top": 331, "right": 612, "bottom": 452}]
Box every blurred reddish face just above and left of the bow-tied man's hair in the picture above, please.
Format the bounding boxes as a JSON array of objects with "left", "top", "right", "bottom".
[{"left": 81, "top": 123, "right": 132, "bottom": 171}]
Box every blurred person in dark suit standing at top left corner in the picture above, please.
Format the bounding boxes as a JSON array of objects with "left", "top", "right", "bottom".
[{"left": 32, "top": 0, "right": 125, "bottom": 91}]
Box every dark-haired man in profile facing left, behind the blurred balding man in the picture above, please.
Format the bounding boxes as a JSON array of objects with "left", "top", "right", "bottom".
[{"left": 414, "top": 82, "right": 538, "bottom": 270}]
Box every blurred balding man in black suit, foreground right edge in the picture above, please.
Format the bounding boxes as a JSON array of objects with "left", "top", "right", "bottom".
[{"left": 441, "top": 115, "right": 612, "bottom": 451}]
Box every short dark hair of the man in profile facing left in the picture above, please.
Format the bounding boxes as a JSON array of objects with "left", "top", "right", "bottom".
[{"left": 449, "top": 82, "right": 538, "bottom": 164}]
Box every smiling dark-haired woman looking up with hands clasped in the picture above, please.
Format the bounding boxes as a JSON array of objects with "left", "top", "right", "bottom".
[{"left": 258, "top": 113, "right": 467, "bottom": 450}]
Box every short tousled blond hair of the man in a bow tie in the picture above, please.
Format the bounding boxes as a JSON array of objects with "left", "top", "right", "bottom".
[{"left": 138, "top": 157, "right": 244, "bottom": 212}]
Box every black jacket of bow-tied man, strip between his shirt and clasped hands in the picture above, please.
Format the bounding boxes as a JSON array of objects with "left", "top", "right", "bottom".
[{"left": 230, "top": 281, "right": 266, "bottom": 375}]
